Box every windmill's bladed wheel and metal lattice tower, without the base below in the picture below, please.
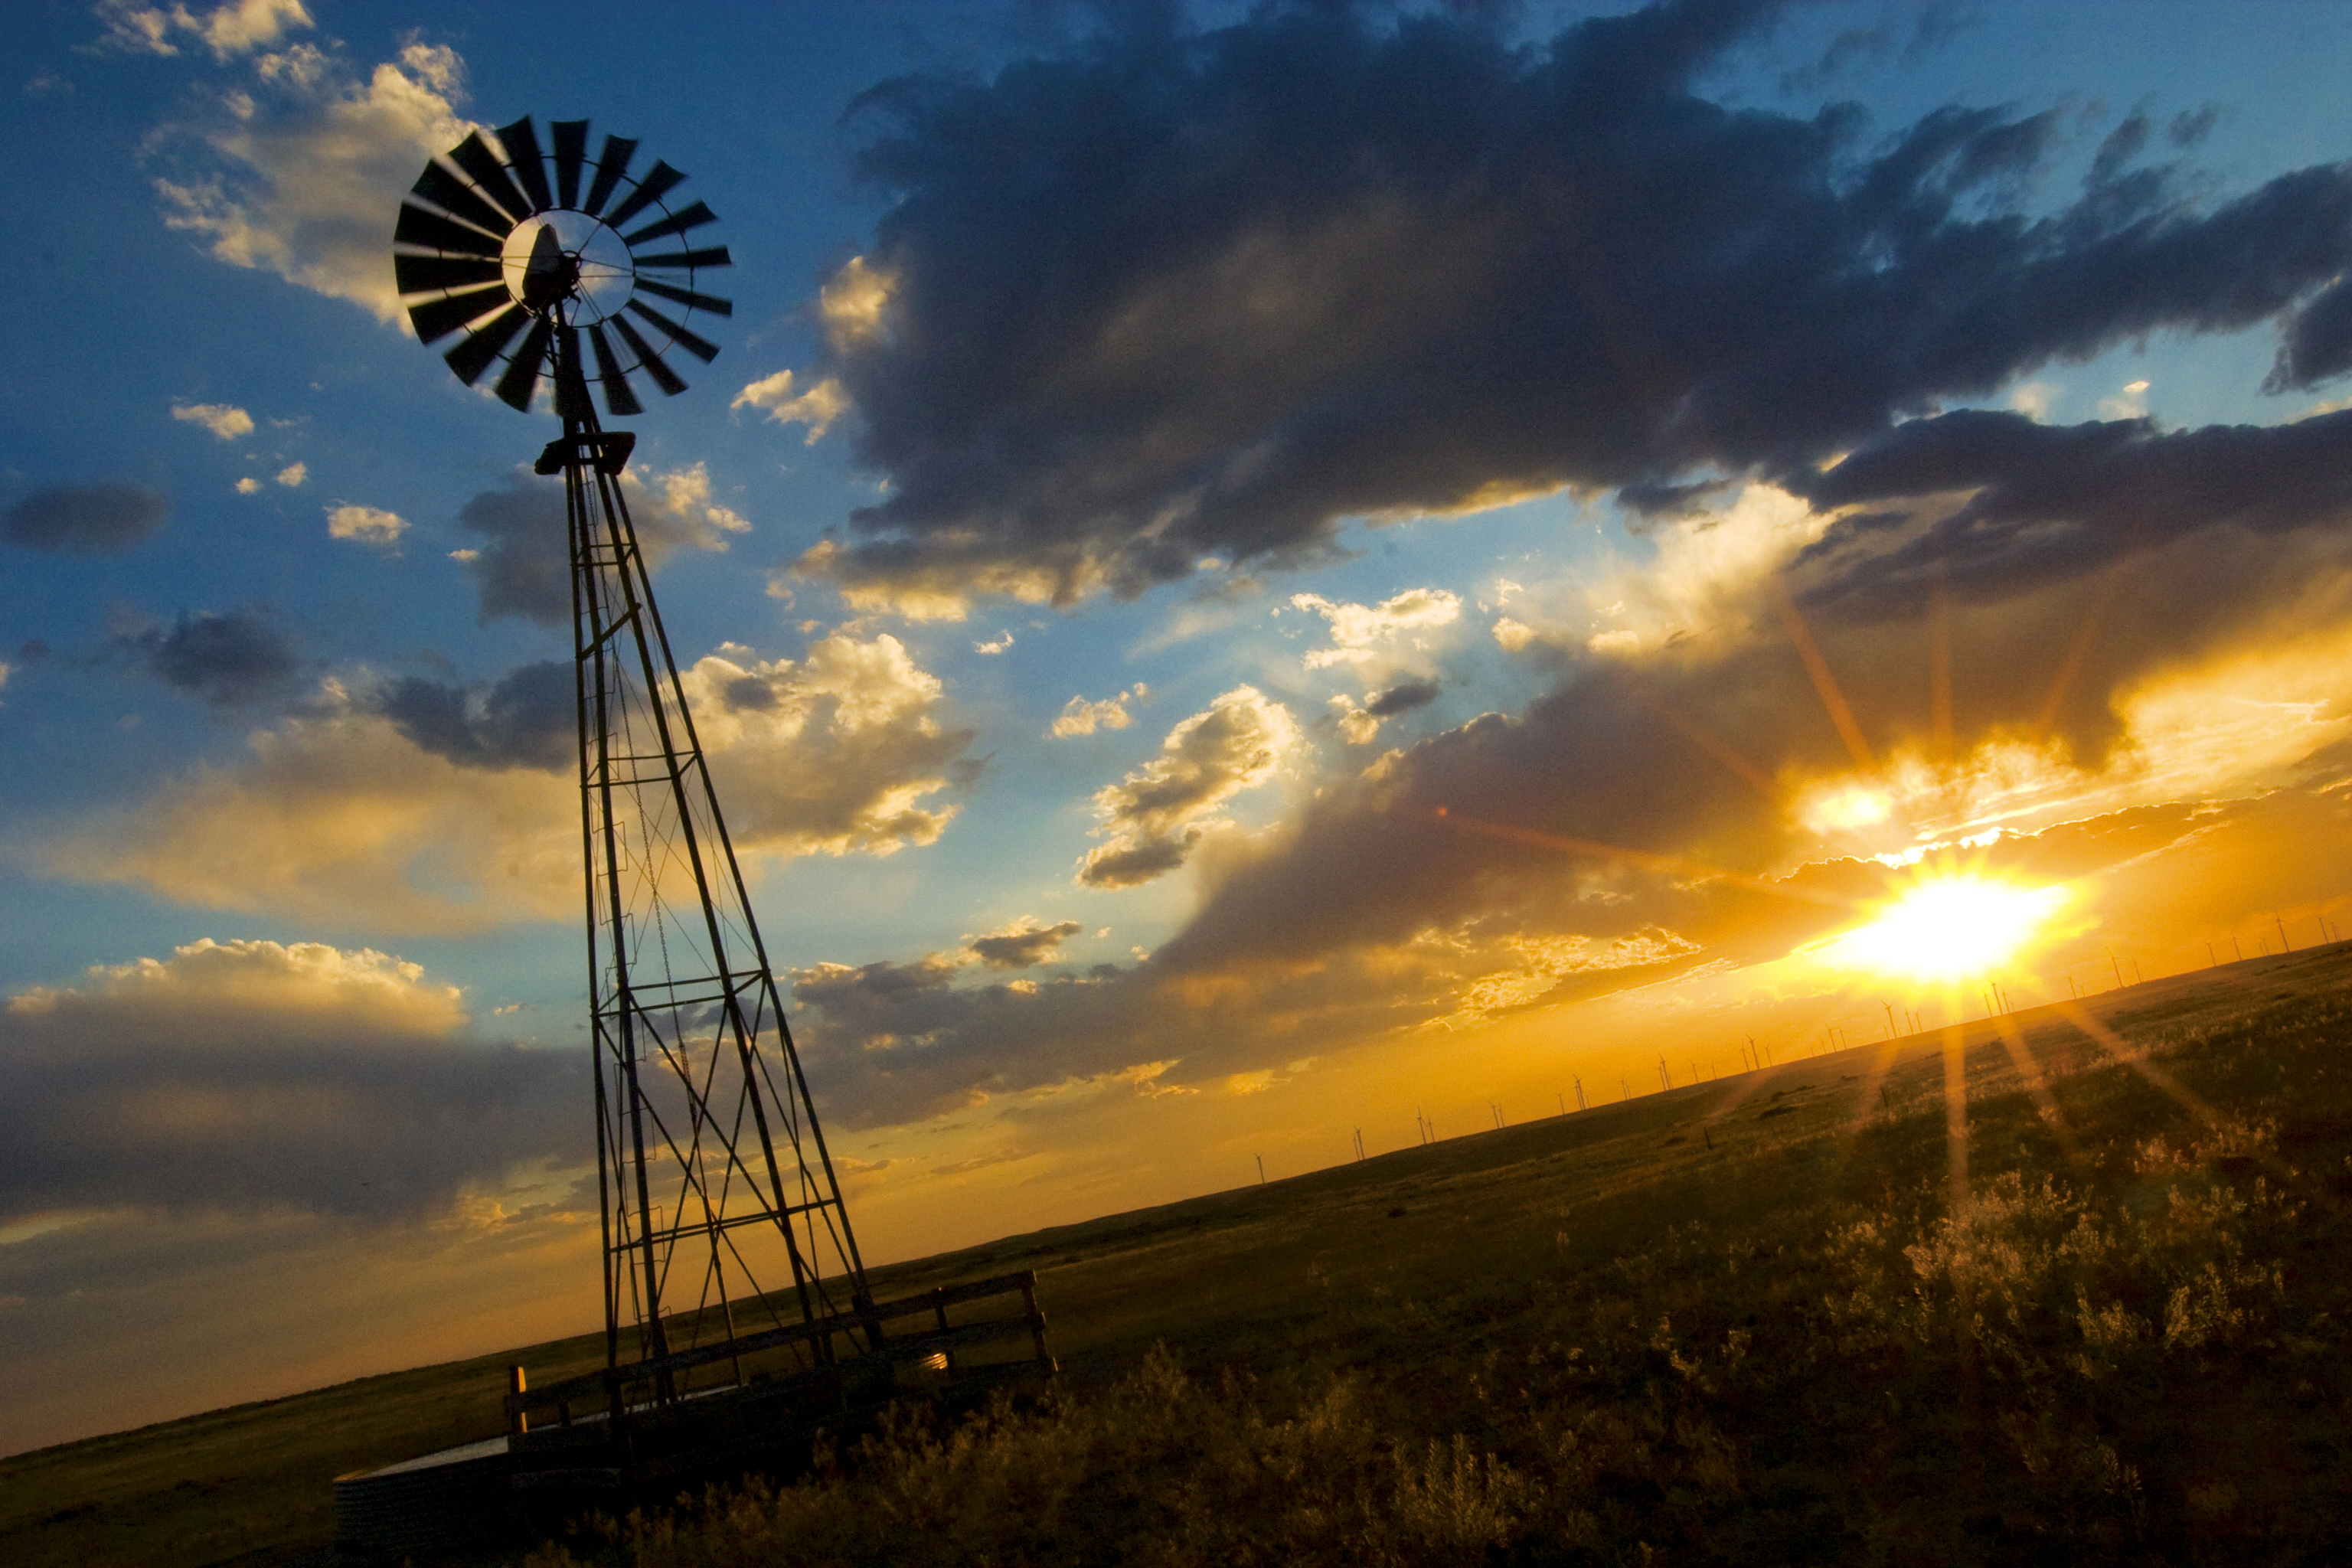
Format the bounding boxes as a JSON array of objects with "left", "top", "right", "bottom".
[{"left": 393, "top": 120, "right": 873, "bottom": 1413}]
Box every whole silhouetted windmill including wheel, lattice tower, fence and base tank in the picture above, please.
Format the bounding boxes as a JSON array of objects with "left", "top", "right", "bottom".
[{"left": 334, "top": 118, "right": 1056, "bottom": 1557}]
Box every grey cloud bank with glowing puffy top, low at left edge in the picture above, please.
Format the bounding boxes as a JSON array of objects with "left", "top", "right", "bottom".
[{"left": 0, "top": 942, "right": 588, "bottom": 1218}]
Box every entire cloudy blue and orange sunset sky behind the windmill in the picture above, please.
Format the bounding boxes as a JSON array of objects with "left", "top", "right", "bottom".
[{"left": 0, "top": 0, "right": 2352, "bottom": 1450}]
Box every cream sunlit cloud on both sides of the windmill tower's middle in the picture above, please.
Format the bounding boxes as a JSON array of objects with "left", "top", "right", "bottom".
[{"left": 42, "top": 635, "right": 974, "bottom": 933}]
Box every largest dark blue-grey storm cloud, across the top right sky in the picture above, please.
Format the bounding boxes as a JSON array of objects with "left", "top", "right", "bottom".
[{"left": 805, "top": 0, "right": 2352, "bottom": 597}]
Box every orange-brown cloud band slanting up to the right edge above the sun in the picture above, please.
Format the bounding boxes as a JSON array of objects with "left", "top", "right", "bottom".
[{"left": 1155, "top": 512, "right": 2352, "bottom": 973}]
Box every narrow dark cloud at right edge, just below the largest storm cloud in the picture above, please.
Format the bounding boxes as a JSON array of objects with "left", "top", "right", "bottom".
[{"left": 1799, "top": 409, "right": 2352, "bottom": 619}]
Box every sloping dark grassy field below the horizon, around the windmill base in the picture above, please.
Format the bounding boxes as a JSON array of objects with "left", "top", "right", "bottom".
[{"left": 0, "top": 947, "right": 2352, "bottom": 1568}]
